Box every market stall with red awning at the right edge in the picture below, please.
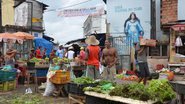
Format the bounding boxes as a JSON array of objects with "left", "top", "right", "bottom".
[{"left": 168, "top": 24, "right": 185, "bottom": 104}]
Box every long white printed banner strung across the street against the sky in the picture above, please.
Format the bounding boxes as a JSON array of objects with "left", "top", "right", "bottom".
[{"left": 58, "top": 6, "right": 104, "bottom": 17}]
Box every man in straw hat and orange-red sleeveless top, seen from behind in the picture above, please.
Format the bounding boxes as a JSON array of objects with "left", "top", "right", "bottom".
[{"left": 85, "top": 35, "right": 101, "bottom": 79}]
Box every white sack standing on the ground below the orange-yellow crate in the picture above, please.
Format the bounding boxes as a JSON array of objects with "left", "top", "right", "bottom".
[{"left": 43, "top": 79, "right": 55, "bottom": 96}]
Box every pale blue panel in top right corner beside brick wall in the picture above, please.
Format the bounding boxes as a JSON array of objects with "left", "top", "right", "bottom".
[{"left": 178, "top": 0, "right": 185, "bottom": 20}]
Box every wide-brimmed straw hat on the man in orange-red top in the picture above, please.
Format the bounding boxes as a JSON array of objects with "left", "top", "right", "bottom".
[{"left": 85, "top": 35, "right": 100, "bottom": 45}]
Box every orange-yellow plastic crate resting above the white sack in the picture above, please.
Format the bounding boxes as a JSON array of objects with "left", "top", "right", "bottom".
[{"left": 50, "top": 70, "right": 70, "bottom": 84}]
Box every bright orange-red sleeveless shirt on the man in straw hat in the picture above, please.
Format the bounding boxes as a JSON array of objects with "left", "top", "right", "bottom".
[{"left": 87, "top": 46, "right": 100, "bottom": 68}]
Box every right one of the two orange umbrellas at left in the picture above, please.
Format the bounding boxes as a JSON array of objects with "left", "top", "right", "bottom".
[{"left": 13, "top": 32, "right": 34, "bottom": 40}]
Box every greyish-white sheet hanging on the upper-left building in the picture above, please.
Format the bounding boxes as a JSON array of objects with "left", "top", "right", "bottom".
[{"left": 15, "top": 3, "right": 28, "bottom": 26}]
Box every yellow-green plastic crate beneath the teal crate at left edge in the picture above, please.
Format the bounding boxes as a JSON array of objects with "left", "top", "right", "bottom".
[{"left": 0, "top": 80, "right": 16, "bottom": 91}]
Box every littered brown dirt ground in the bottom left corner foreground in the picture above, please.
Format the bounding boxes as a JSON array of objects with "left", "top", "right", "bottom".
[{"left": 0, "top": 85, "right": 68, "bottom": 104}]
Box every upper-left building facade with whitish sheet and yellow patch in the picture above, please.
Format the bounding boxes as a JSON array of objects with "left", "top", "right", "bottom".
[{"left": 14, "top": 0, "right": 48, "bottom": 37}]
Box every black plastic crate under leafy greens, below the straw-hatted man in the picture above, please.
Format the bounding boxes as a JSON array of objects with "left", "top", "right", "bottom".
[{"left": 68, "top": 82, "right": 97, "bottom": 96}]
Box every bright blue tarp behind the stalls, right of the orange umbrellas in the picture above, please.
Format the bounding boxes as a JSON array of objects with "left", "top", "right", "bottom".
[{"left": 34, "top": 38, "right": 53, "bottom": 56}]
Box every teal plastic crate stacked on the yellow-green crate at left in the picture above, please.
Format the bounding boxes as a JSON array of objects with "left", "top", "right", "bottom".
[{"left": 0, "top": 70, "right": 16, "bottom": 82}]
